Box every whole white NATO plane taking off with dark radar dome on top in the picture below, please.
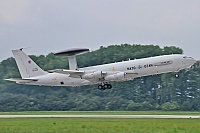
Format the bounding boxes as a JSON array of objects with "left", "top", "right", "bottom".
[{"left": 5, "top": 48, "right": 196, "bottom": 90}]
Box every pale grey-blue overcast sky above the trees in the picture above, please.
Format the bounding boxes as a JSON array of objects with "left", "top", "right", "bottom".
[{"left": 0, "top": 0, "right": 200, "bottom": 61}]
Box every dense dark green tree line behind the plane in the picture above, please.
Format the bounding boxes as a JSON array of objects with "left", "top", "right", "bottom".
[{"left": 0, "top": 44, "right": 200, "bottom": 111}]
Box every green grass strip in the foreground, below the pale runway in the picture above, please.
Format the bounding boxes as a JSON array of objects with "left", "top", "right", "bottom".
[{"left": 0, "top": 118, "right": 200, "bottom": 133}]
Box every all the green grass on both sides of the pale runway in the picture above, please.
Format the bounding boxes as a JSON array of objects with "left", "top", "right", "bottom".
[{"left": 0, "top": 111, "right": 200, "bottom": 133}]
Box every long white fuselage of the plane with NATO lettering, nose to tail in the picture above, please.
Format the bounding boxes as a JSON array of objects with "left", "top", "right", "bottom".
[{"left": 20, "top": 54, "right": 196, "bottom": 86}]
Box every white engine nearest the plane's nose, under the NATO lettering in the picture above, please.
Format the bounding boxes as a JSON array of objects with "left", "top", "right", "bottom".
[{"left": 105, "top": 72, "right": 125, "bottom": 81}]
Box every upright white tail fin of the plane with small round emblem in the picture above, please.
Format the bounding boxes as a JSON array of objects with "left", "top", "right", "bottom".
[{"left": 12, "top": 49, "right": 47, "bottom": 79}]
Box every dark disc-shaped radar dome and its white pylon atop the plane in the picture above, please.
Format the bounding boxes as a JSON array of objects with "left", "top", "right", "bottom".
[{"left": 54, "top": 48, "right": 89, "bottom": 70}]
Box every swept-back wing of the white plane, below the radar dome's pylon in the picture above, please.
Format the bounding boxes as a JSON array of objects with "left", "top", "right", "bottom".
[{"left": 48, "top": 69, "right": 85, "bottom": 78}]
